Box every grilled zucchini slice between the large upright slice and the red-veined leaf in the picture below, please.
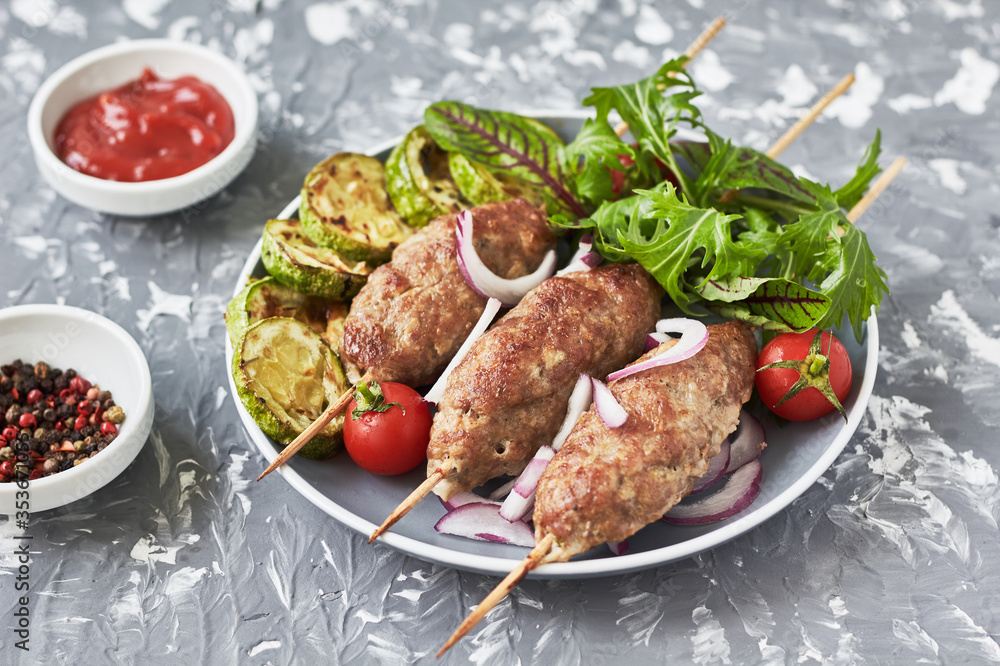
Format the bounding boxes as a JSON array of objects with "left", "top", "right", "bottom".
[{"left": 385, "top": 125, "right": 462, "bottom": 227}]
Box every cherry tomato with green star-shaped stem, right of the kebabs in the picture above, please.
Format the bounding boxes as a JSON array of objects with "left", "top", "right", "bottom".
[{"left": 756, "top": 329, "right": 854, "bottom": 421}]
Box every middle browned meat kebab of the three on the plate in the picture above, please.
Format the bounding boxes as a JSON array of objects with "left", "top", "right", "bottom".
[{"left": 427, "top": 264, "right": 662, "bottom": 499}]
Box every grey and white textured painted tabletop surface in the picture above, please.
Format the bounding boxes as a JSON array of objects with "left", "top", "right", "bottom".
[{"left": 0, "top": 0, "right": 1000, "bottom": 664}]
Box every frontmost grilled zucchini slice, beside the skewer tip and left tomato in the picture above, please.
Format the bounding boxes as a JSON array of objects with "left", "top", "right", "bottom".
[{"left": 232, "top": 317, "right": 349, "bottom": 459}]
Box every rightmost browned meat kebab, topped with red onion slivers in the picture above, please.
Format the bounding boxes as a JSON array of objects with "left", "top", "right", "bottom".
[{"left": 534, "top": 322, "right": 757, "bottom": 562}]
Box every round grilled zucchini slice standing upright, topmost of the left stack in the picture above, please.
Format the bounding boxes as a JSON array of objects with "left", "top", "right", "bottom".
[{"left": 299, "top": 153, "right": 411, "bottom": 265}]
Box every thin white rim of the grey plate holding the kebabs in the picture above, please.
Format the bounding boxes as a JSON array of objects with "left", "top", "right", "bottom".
[{"left": 226, "top": 109, "right": 879, "bottom": 579}]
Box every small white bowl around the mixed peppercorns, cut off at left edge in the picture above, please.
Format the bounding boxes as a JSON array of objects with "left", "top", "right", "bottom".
[{"left": 0, "top": 305, "right": 153, "bottom": 515}]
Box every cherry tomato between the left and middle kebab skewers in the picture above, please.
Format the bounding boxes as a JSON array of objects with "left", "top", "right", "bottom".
[{"left": 344, "top": 382, "right": 431, "bottom": 476}]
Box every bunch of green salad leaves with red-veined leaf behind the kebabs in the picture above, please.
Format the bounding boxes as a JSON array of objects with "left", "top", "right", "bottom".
[{"left": 424, "top": 57, "right": 889, "bottom": 340}]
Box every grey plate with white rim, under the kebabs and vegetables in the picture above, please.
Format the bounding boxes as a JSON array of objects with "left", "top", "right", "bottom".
[{"left": 226, "top": 112, "right": 878, "bottom": 578}]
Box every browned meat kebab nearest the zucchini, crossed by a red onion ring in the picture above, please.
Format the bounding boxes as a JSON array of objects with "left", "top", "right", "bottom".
[{"left": 341, "top": 199, "right": 556, "bottom": 386}]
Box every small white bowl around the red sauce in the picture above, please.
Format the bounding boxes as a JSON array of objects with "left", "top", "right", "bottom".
[{"left": 28, "top": 39, "right": 257, "bottom": 216}]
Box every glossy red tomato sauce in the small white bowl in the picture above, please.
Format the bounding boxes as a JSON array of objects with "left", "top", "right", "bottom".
[{"left": 55, "top": 67, "right": 236, "bottom": 182}]
